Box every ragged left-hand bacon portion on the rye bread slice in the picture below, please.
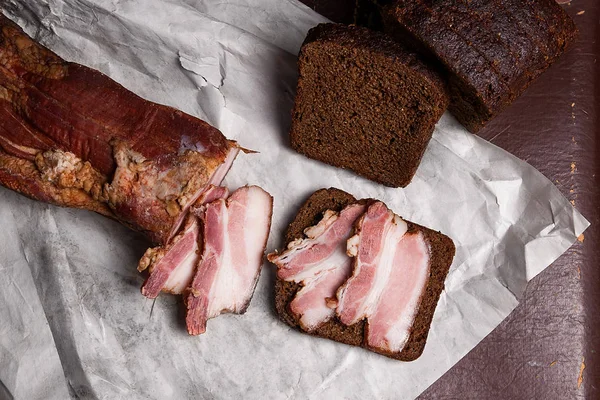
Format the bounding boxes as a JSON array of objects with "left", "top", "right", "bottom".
[{"left": 268, "top": 204, "right": 366, "bottom": 332}]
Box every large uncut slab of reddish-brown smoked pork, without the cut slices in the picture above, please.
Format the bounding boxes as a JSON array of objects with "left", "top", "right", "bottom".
[{"left": 0, "top": 14, "right": 239, "bottom": 244}]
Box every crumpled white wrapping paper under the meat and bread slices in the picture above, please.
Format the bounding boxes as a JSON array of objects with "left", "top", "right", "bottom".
[{"left": 0, "top": 0, "right": 589, "bottom": 399}]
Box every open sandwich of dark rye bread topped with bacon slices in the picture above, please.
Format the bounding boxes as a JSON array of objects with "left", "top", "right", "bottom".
[{"left": 269, "top": 188, "right": 455, "bottom": 361}]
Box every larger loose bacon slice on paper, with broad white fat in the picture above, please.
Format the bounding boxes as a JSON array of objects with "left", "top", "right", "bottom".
[{"left": 186, "top": 186, "right": 273, "bottom": 335}]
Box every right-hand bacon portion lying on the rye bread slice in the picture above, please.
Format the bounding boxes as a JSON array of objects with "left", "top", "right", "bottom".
[{"left": 336, "top": 202, "right": 430, "bottom": 353}]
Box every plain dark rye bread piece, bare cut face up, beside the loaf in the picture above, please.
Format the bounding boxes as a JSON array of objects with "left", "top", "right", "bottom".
[{"left": 290, "top": 24, "right": 449, "bottom": 187}]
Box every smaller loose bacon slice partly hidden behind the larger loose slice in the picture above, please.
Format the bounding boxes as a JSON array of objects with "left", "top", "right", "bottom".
[{"left": 138, "top": 185, "right": 229, "bottom": 299}]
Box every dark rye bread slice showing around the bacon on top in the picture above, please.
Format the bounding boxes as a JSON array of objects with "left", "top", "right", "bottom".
[{"left": 275, "top": 188, "right": 455, "bottom": 361}]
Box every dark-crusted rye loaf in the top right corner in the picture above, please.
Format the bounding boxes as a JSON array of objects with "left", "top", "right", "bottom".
[{"left": 383, "top": 0, "right": 577, "bottom": 132}]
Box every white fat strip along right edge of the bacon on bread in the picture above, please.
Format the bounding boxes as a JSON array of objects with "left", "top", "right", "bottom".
[{"left": 385, "top": 233, "right": 429, "bottom": 352}]
